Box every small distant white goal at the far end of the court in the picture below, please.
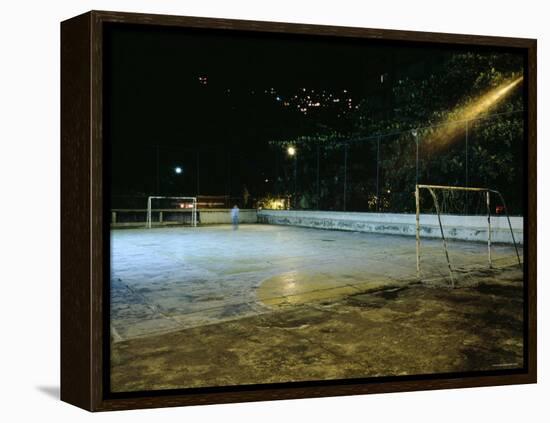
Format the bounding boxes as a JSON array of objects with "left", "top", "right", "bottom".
[{"left": 147, "top": 196, "right": 197, "bottom": 229}]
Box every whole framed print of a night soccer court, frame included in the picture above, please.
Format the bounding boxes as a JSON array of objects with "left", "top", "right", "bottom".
[{"left": 61, "top": 11, "right": 536, "bottom": 411}]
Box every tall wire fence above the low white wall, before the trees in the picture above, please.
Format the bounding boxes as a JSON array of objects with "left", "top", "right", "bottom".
[{"left": 271, "top": 112, "right": 525, "bottom": 215}]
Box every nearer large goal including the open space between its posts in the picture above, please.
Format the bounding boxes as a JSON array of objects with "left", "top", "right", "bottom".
[{"left": 415, "top": 185, "right": 521, "bottom": 287}]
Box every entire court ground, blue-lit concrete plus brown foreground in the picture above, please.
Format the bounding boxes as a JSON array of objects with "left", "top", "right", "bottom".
[{"left": 111, "top": 225, "right": 523, "bottom": 391}]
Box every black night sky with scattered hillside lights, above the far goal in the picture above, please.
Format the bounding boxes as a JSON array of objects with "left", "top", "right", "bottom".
[{"left": 104, "top": 24, "right": 516, "bottom": 206}]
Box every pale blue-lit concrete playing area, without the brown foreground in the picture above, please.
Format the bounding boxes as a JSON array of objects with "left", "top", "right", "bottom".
[{"left": 111, "top": 225, "right": 515, "bottom": 341}]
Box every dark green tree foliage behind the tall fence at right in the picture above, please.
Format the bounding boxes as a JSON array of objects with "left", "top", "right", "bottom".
[{"left": 274, "top": 51, "right": 524, "bottom": 214}]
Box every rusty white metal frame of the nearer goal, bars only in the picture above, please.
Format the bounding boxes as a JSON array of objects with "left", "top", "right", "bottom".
[{"left": 415, "top": 185, "right": 521, "bottom": 287}]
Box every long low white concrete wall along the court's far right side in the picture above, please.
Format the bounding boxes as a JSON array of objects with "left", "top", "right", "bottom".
[{"left": 258, "top": 210, "right": 523, "bottom": 244}]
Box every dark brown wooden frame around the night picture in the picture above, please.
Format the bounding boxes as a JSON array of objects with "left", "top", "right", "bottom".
[{"left": 61, "top": 11, "right": 537, "bottom": 411}]
